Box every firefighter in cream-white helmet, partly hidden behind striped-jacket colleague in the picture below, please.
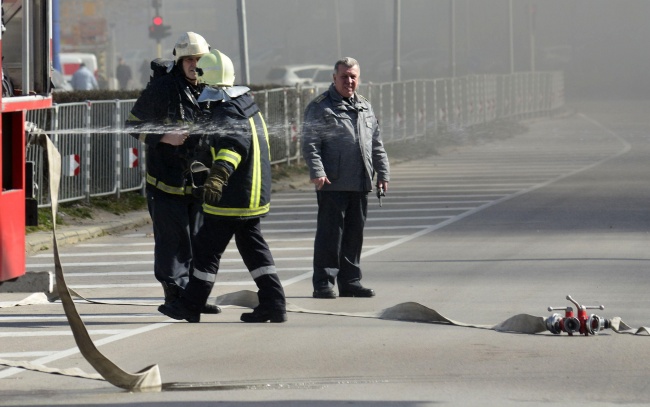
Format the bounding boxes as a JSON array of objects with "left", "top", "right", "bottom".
[{"left": 126, "top": 32, "right": 220, "bottom": 314}]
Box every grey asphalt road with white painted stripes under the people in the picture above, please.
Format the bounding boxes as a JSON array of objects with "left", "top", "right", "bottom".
[{"left": 0, "top": 101, "right": 650, "bottom": 407}]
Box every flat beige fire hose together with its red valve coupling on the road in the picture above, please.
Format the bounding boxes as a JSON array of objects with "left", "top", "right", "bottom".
[{"left": 0, "top": 133, "right": 650, "bottom": 390}]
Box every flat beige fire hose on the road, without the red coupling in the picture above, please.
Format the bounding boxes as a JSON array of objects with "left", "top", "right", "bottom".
[{"left": 0, "top": 133, "right": 650, "bottom": 391}]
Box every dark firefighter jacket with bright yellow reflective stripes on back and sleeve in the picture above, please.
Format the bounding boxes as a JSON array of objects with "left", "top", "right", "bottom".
[{"left": 203, "top": 93, "right": 271, "bottom": 218}]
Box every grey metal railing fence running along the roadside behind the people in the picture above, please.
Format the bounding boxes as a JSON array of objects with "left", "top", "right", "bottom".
[{"left": 27, "top": 72, "right": 564, "bottom": 207}]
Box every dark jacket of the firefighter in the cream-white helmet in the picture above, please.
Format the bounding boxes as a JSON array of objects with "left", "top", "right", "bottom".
[{"left": 126, "top": 66, "right": 206, "bottom": 196}]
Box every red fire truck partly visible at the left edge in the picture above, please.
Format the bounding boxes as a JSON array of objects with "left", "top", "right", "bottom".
[{"left": 0, "top": 0, "right": 52, "bottom": 284}]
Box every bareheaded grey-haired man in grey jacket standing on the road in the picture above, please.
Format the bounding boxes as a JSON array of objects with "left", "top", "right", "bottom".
[{"left": 302, "top": 58, "right": 389, "bottom": 298}]
